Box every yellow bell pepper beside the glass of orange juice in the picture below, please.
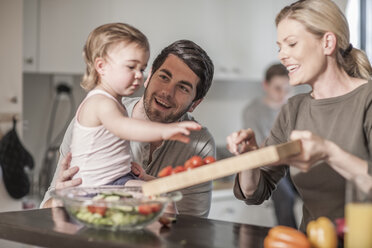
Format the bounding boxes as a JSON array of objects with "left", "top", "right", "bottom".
[{"left": 306, "top": 217, "right": 337, "bottom": 248}]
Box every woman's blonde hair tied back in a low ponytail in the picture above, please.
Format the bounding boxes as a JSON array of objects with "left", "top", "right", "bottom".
[{"left": 275, "top": 0, "right": 372, "bottom": 80}]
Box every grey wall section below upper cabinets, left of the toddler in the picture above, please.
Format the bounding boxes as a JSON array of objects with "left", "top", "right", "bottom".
[{"left": 23, "top": 73, "right": 85, "bottom": 190}]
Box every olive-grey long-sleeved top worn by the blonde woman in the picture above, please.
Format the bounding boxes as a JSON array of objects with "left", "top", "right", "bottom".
[{"left": 234, "top": 81, "right": 372, "bottom": 230}]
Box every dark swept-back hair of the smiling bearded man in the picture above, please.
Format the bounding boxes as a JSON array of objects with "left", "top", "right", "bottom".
[{"left": 152, "top": 40, "right": 214, "bottom": 101}]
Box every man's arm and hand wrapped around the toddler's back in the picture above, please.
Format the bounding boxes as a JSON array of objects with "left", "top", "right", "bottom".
[{"left": 40, "top": 119, "right": 81, "bottom": 208}]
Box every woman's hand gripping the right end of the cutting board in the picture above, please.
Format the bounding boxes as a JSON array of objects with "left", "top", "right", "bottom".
[{"left": 285, "top": 131, "right": 331, "bottom": 172}]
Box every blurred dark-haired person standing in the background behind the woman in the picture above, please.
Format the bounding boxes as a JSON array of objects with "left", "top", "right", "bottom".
[{"left": 243, "top": 64, "right": 297, "bottom": 228}]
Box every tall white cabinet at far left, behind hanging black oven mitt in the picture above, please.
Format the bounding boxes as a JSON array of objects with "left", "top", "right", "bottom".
[{"left": 0, "top": 0, "right": 23, "bottom": 211}]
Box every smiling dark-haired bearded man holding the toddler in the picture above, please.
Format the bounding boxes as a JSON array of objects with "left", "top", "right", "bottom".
[{"left": 41, "top": 40, "right": 215, "bottom": 217}]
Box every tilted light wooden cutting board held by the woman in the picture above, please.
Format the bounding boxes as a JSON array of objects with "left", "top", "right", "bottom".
[{"left": 142, "top": 140, "right": 301, "bottom": 196}]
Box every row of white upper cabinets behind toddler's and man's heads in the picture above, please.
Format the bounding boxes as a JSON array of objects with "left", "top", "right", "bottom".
[{"left": 24, "top": 0, "right": 292, "bottom": 81}]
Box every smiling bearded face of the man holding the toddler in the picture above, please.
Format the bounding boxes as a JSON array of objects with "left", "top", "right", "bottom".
[{"left": 144, "top": 54, "right": 200, "bottom": 123}]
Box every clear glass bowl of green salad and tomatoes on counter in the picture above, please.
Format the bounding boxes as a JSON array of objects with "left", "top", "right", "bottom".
[{"left": 51, "top": 186, "right": 182, "bottom": 230}]
